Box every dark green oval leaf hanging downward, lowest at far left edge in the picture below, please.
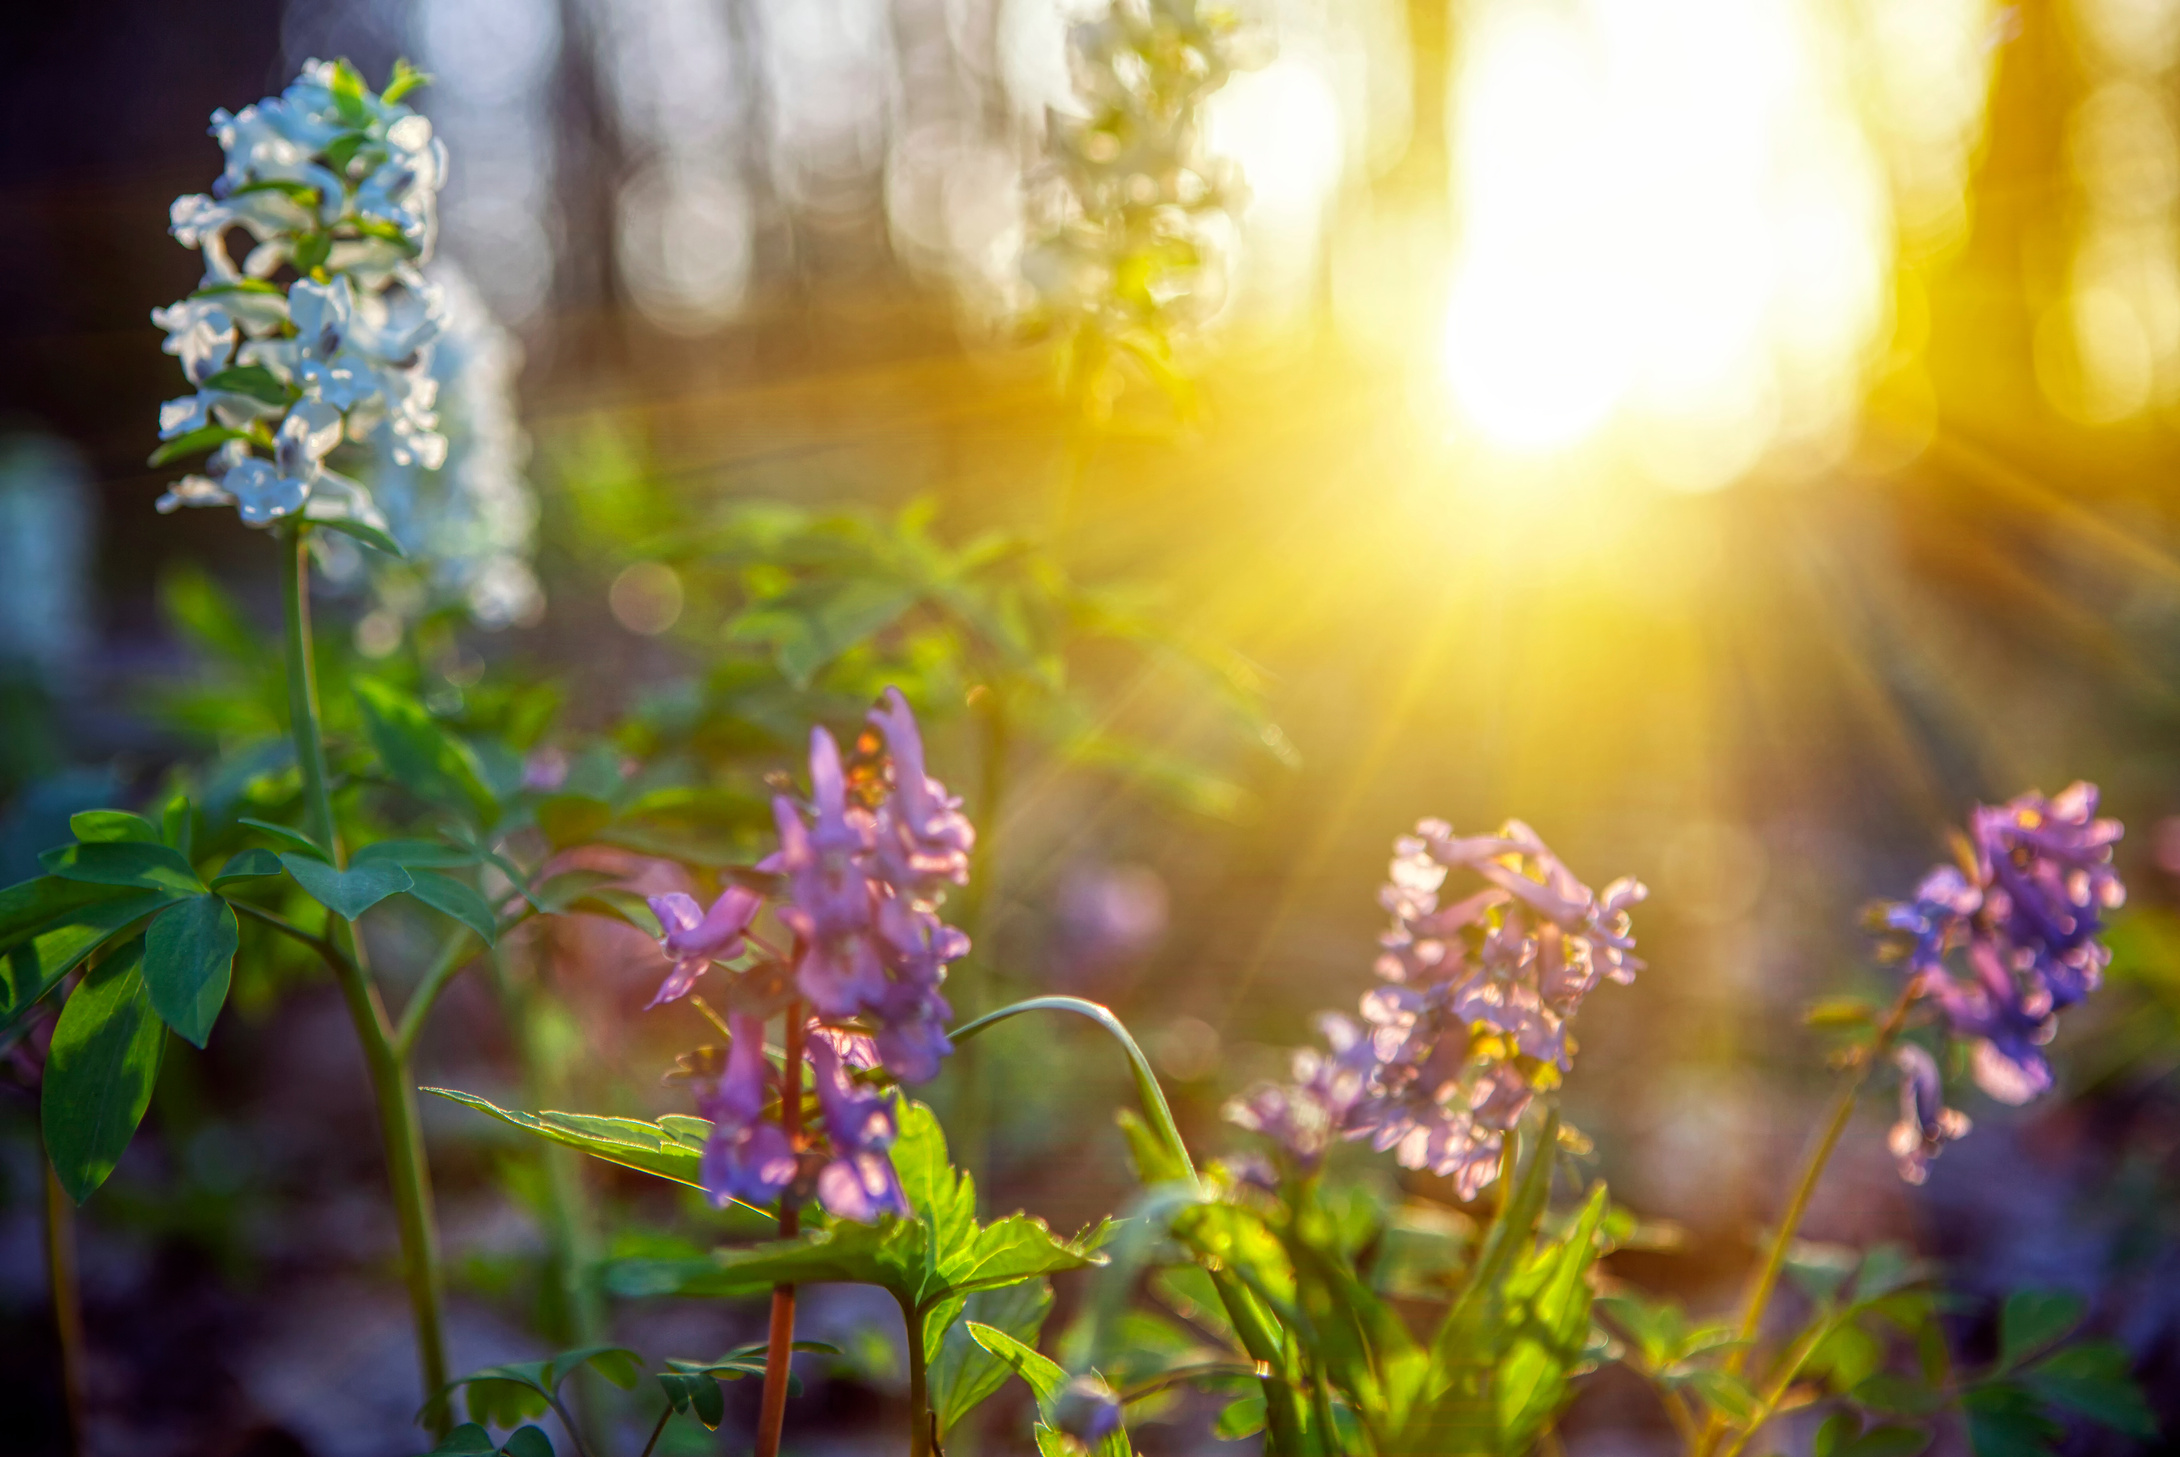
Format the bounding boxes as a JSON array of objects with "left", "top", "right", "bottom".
[{"left": 39, "top": 940, "right": 166, "bottom": 1204}]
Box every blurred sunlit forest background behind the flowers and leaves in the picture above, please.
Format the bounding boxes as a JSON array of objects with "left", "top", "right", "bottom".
[{"left": 0, "top": 0, "right": 2180, "bottom": 1457}]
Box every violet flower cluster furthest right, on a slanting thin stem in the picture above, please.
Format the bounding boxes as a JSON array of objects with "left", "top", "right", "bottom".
[{"left": 1879, "top": 783, "right": 2126, "bottom": 1182}]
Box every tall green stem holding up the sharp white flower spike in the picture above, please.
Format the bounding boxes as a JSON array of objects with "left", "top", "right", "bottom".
[{"left": 281, "top": 521, "right": 451, "bottom": 1435}]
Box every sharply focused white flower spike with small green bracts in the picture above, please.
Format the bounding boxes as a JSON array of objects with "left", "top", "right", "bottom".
[{"left": 153, "top": 61, "right": 447, "bottom": 530}]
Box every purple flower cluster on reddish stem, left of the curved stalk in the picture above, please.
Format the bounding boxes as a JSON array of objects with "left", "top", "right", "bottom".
[{"left": 650, "top": 689, "right": 977, "bottom": 1219}]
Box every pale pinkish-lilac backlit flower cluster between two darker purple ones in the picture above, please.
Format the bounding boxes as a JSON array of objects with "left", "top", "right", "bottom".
[{"left": 1227, "top": 820, "right": 1646, "bottom": 1197}]
